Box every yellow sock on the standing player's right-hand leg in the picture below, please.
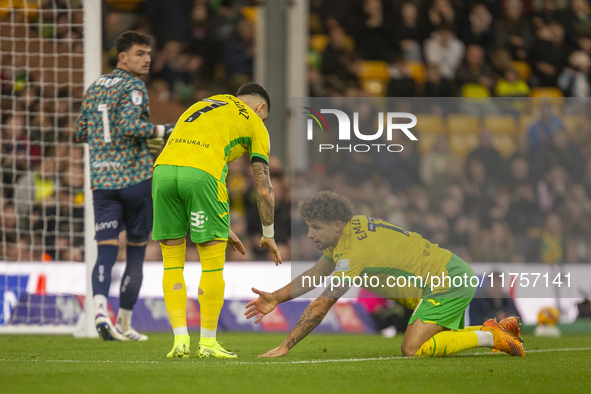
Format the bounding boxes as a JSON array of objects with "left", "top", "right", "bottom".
[{"left": 197, "top": 242, "right": 227, "bottom": 332}]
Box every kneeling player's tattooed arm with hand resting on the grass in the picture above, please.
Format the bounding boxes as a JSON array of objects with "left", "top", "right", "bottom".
[{"left": 259, "top": 285, "right": 350, "bottom": 357}]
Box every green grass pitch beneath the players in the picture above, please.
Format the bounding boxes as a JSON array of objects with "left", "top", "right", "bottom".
[{"left": 0, "top": 333, "right": 591, "bottom": 394}]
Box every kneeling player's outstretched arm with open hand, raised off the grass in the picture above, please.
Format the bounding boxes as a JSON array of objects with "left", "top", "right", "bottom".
[{"left": 244, "top": 257, "right": 334, "bottom": 323}]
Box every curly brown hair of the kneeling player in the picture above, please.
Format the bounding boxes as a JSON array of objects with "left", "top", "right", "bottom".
[{"left": 298, "top": 191, "right": 353, "bottom": 223}]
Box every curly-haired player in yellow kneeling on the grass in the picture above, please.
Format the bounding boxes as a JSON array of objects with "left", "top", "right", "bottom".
[{"left": 245, "top": 192, "right": 525, "bottom": 357}]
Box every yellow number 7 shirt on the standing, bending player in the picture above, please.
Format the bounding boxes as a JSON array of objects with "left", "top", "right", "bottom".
[{"left": 154, "top": 94, "right": 270, "bottom": 183}]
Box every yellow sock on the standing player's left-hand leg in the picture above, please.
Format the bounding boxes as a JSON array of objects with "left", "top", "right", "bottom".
[{"left": 160, "top": 242, "right": 187, "bottom": 330}]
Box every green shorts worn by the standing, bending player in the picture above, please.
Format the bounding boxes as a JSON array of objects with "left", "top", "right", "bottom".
[{"left": 152, "top": 165, "right": 230, "bottom": 243}]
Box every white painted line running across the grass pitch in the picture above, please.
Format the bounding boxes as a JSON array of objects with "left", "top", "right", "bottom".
[{"left": 0, "top": 347, "right": 591, "bottom": 365}]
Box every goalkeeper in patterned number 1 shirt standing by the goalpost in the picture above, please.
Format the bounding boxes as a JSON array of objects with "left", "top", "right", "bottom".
[{"left": 76, "top": 31, "right": 173, "bottom": 341}]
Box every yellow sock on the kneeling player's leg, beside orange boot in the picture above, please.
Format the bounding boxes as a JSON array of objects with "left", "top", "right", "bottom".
[{"left": 415, "top": 331, "right": 478, "bottom": 357}]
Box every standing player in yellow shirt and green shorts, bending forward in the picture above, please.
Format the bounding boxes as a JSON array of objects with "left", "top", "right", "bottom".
[{"left": 152, "top": 83, "right": 281, "bottom": 358}]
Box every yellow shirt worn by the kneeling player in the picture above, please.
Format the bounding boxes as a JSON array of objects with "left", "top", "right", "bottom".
[{"left": 324, "top": 215, "right": 451, "bottom": 309}]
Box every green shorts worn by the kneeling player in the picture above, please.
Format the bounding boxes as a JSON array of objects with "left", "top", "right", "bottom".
[{"left": 408, "top": 254, "right": 476, "bottom": 330}]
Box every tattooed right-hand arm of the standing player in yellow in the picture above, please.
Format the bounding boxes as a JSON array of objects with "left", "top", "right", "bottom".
[{"left": 252, "top": 161, "right": 281, "bottom": 265}]
